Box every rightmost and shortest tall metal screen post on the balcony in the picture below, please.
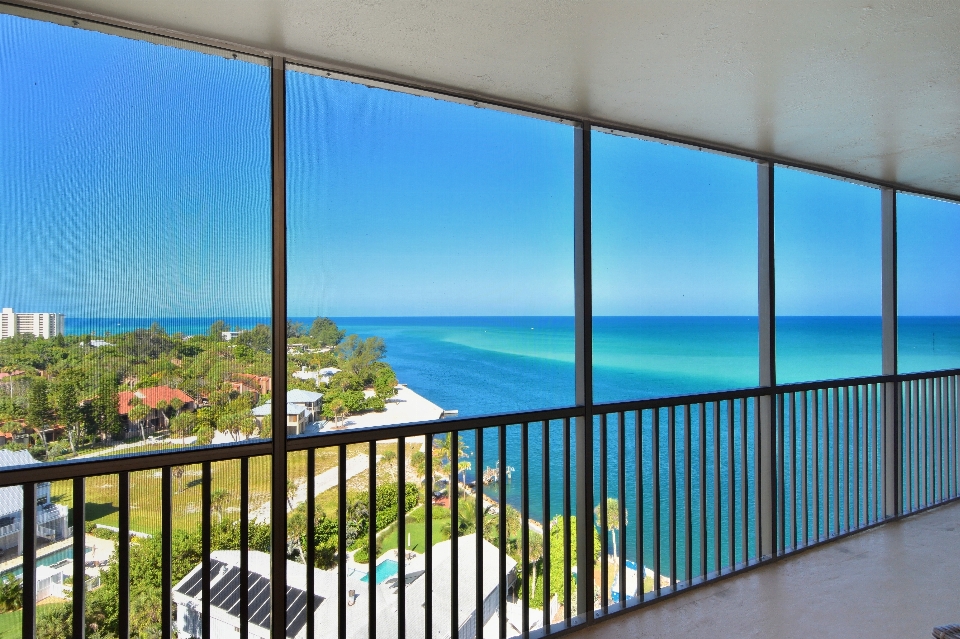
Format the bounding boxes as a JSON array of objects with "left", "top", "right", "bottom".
[{"left": 880, "top": 188, "right": 903, "bottom": 518}]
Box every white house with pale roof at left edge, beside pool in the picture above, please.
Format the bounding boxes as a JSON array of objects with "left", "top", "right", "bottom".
[{"left": 0, "top": 450, "right": 70, "bottom": 561}]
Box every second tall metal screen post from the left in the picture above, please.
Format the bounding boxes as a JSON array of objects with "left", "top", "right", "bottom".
[{"left": 573, "top": 122, "right": 594, "bottom": 623}]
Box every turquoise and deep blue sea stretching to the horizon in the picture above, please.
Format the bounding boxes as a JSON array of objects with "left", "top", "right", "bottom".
[{"left": 66, "top": 317, "right": 960, "bottom": 578}]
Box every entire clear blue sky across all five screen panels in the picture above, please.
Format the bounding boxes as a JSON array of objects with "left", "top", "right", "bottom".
[{"left": 0, "top": 15, "right": 960, "bottom": 317}]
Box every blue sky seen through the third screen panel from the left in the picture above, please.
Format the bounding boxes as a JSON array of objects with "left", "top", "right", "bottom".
[{"left": 592, "top": 133, "right": 757, "bottom": 316}]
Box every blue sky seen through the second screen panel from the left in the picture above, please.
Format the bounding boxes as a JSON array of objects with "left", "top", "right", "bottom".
[{"left": 287, "top": 72, "right": 573, "bottom": 316}]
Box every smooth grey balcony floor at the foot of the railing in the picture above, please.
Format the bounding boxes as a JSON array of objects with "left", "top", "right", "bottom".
[{"left": 577, "top": 502, "right": 960, "bottom": 639}]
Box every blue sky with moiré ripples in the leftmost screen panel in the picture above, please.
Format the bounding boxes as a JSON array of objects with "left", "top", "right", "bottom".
[{"left": 0, "top": 15, "right": 270, "bottom": 317}]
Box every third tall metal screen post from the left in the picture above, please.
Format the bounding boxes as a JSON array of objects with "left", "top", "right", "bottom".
[{"left": 754, "top": 162, "right": 778, "bottom": 559}]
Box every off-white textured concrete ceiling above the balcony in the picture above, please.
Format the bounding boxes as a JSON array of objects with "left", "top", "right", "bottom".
[{"left": 26, "top": 0, "right": 960, "bottom": 197}]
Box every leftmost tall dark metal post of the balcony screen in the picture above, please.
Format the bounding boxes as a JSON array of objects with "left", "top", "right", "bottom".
[{"left": 270, "top": 56, "right": 288, "bottom": 639}]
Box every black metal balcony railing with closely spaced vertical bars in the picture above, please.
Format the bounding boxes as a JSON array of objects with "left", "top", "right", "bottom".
[{"left": 0, "top": 370, "right": 960, "bottom": 639}]
